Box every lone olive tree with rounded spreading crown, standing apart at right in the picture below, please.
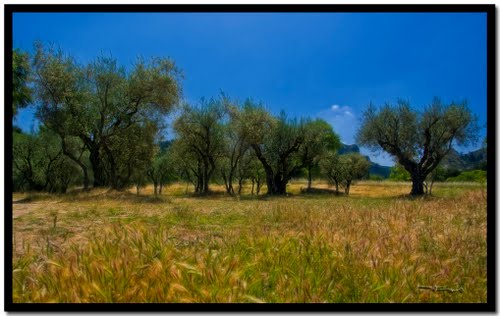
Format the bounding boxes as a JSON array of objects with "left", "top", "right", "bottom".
[{"left": 357, "top": 98, "right": 478, "bottom": 195}]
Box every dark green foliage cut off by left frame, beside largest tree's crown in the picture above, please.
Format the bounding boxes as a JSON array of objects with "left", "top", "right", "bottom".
[{"left": 12, "top": 48, "right": 33, "bottom": 116}]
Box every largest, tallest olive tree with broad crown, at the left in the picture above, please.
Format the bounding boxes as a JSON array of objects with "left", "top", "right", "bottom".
[{"left": 33, "top": 43, "right": 181, "bottom": 189}]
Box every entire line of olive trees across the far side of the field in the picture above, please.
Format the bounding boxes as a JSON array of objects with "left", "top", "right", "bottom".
[{"left": 12, "top": 42, "right": 477, "bottom": 195}]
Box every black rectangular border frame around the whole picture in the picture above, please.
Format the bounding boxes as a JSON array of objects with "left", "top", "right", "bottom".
[{"left": 4, "top": 4, "right": 497, "bottom": 312}]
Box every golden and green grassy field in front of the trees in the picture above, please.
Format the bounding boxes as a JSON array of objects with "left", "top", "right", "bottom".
[{"left": 13, "top": 181, "right": 486, "bottom": 302}]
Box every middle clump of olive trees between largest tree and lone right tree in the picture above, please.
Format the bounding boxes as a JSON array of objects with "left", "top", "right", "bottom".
[{"left": 173, "top": 96, "right": 348, "bottom": 194}]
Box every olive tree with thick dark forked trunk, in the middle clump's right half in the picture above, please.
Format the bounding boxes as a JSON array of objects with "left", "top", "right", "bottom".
[{"left": 236, "top": 100, "right": 340, "bottom": 195}]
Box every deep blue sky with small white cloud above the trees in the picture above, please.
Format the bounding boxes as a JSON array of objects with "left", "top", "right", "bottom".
[{"left": 13, "top": 13, "right": 486, "bottom": 165}]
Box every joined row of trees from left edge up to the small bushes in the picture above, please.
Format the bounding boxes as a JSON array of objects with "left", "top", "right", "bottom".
[{"left": 13, "top": 43, "right": 372, "bottom": 194}]
